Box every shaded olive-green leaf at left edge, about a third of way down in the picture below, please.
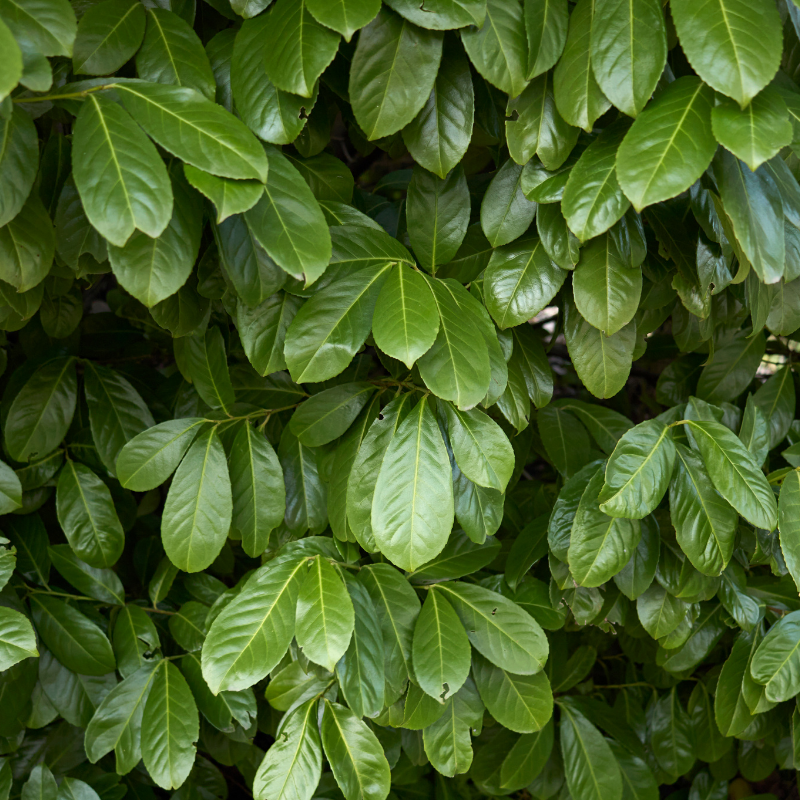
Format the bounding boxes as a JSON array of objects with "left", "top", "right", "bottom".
[{"left": 0, "top": 193, "right": 55, "bottom": 292}]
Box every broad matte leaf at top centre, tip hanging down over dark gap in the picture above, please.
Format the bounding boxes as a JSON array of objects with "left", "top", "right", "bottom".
[{"left": 349, "top": 8, "right": 442, "bottom": 140}]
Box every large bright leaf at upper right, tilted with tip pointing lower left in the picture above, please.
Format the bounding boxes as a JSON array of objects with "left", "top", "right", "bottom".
[{"left": 617, "top": 76, "right": 717, "bottom": 211}]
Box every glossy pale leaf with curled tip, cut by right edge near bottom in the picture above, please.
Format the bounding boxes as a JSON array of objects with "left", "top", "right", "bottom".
[{"left": 750, "top": 611, "right": 800, "bottom": 703}]
